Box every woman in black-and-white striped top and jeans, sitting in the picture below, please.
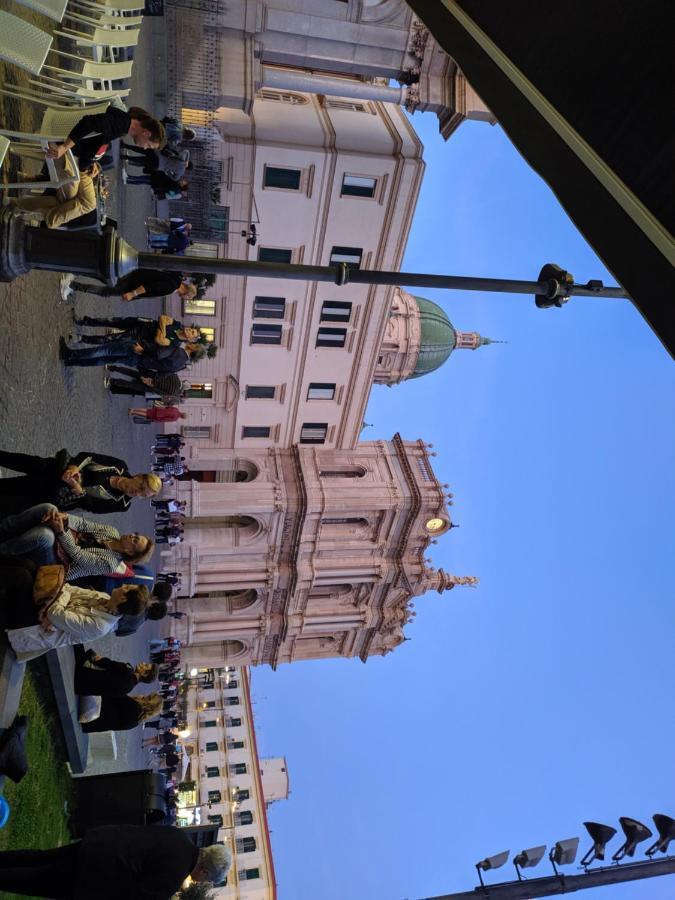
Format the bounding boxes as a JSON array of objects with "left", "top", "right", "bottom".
[{"left": 0, "top": 503, "right": 155, "bottom": 580}]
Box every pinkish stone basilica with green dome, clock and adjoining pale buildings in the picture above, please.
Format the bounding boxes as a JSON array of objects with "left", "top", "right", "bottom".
[{"left": 162, "top": 0, "right": 496, "bottom": 667}]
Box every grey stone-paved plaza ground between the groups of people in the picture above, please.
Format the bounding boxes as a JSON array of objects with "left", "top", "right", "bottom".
[{"left": 0, "top": 22, "right": 174, "bottom": 774}]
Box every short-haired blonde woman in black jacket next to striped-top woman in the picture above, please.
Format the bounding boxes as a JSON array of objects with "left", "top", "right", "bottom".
[{"left": 0, "top": 449, "right": 162, "bottom": 515}]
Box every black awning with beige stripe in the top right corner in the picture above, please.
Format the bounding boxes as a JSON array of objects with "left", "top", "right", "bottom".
[{"left": 407, "top": 0, "right": 675, "bottom": 356}]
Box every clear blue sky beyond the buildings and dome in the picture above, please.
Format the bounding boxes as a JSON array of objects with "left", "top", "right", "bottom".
[{"left": 253, "top": 115, "right": 675, "bottom": 900}]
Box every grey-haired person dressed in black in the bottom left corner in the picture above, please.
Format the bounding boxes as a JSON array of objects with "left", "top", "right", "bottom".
[{"left": 0, "top": 825, "right": 232, "bottom": 900}]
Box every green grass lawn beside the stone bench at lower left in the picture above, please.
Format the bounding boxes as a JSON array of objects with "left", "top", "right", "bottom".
[{"left": 0, "top": 663, "right": 71, "bottom": 900}]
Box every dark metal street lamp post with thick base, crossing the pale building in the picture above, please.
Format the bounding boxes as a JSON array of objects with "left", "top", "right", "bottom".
[{"left": 0, "top": 207, "right": 628, "bottom": 308}]
